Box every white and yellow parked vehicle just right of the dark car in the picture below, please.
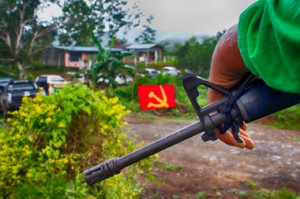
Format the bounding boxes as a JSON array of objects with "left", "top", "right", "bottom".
[{"left": 35, "top": 75, "right": 68, "bottom": 95}]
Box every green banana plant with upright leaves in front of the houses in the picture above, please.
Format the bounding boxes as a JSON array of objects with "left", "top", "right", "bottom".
[{"left": 88, "top": 36, "right": 133, "bottom": 91}]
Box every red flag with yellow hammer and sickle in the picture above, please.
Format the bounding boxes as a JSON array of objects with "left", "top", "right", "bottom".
[{"left": 138, "top": 84, "right": 175, "bottom": 110}]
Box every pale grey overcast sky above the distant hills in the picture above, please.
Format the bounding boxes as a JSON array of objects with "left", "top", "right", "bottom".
[{"left": 135, "top": 0, "right": 256, "bottom": 35}]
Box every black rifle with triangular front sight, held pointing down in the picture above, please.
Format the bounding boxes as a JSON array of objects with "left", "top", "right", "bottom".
[{"left": 83, "top": 74, "right": 300, "bottom": 185}]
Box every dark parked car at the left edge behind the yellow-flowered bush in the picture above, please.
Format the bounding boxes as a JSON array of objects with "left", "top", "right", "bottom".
[{"left": 0, "top": 80, "right": 39, "bottom": 117}]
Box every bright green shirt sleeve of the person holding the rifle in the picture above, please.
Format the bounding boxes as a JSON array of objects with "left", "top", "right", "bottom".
[{"left": 238, "top": 0, "right": 300, "bottom": 93}]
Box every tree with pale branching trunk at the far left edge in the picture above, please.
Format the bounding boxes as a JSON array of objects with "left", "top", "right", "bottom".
[{"left": 0, "top": 0, "right": 56, "bottom": 79}]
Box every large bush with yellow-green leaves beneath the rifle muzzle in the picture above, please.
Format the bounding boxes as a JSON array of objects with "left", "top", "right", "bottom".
[{"left": 0, "top": 84, "right": 155, "bottom": 198}]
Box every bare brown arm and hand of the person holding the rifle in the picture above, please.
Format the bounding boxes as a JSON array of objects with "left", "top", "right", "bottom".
[{"left": 208, "top": 26, "right": 254, "bottom": 149}]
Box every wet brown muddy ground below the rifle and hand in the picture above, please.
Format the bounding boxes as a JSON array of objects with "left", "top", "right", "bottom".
[{"left": 126, "top": 117, "right": 300, "bottom": 199}]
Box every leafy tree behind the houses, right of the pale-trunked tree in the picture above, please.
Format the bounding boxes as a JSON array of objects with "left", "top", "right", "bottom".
[{"left": 59, "top": 0, "right": 142, "bottom": 46}]
